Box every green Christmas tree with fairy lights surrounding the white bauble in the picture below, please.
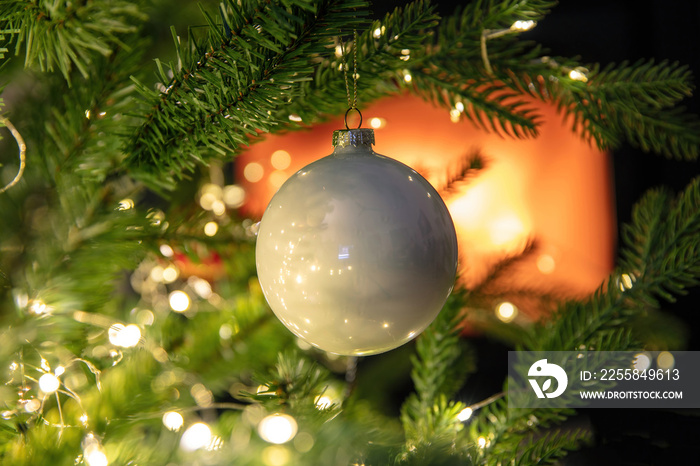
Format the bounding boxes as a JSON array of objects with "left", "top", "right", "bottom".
[{"left": 0, "top": 0, "right": 700, "bottom": 466}]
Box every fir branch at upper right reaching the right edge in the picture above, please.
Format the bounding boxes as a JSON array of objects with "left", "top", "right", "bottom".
[{"left": 504, "top": 57, "right": 700, "bottom": 160}]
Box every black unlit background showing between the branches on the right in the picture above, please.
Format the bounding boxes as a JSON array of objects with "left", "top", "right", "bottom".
[{"left": 363, "top": 0, "right": 700, "bottom": 465}]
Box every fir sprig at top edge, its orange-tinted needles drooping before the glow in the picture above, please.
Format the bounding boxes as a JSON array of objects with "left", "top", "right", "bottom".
[{"left": 410, "top": 1, "right": 554, "bottom": 137}]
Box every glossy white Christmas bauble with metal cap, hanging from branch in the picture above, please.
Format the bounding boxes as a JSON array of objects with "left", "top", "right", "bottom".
[{"left": 256, "top": 129, "right": 457, "bottom": 355}]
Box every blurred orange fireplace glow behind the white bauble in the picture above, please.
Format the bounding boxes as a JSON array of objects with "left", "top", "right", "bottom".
[{"left": 236, "top": 95, "right": 615, "bottom": 312}]
